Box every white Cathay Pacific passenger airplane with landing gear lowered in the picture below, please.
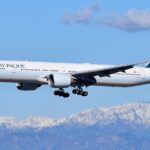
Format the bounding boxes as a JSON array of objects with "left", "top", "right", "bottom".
[{"left": 0, "top": 61, "right": 150, "bottom": 98}]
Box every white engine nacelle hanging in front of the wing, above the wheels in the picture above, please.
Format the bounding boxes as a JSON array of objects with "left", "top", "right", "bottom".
[{"left": 49, "top": 74, "right": 72, "bottom": 88}]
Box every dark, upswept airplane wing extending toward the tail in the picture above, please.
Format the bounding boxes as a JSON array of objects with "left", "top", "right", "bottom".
[{"left": 72, "top": 62, "right": 146, "bottom": 79}]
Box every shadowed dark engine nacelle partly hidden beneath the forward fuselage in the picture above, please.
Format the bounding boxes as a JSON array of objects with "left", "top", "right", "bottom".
[{"left": 16, "top": 83, "right": 41, "bottom": 91}]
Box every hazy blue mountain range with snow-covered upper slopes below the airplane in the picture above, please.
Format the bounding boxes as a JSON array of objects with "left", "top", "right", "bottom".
[{"left": 0, "top": 103, "right": 150, "bottom": 150}]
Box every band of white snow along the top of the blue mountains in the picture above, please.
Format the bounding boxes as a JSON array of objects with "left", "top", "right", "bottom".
[{"left": 0, "top": 103, "right": 150, "bottom": 128}]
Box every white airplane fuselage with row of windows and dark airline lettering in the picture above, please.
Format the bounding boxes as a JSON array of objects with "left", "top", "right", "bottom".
[{"left": 0, "top": 61, "right": 150, "bottom": 87}]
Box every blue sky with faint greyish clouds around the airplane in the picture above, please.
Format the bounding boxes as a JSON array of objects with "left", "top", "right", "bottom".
[{"left": 0, "top": 0, "right": 150, "bottom": 118}]
